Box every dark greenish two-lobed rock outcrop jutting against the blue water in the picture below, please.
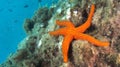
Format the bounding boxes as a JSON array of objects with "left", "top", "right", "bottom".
[{"left": 24, "top": 7, "right": 54, "bottom": 34}]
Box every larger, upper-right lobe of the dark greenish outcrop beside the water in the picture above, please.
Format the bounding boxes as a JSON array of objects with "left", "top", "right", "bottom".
[{"left": 33, "top": 7, "right": 54, "bottom": 27}]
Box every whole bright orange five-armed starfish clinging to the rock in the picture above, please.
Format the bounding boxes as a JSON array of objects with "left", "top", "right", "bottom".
[{"left": 49, "top": 4, "right": 109, "bottom": 62}]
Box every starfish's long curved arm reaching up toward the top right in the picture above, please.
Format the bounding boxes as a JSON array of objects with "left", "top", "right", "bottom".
[{"left": 76, "top": 4, "right": 95, "bottom": 32}]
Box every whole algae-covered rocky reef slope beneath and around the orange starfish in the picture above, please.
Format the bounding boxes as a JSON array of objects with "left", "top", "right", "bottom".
[{"left": 0, "top": 0, "right": 120, "bottom": 67}]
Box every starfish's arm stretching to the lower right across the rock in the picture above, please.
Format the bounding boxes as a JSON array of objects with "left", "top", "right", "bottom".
[{"left": 74, "top": 33, "right": 109, "bottom": 46}]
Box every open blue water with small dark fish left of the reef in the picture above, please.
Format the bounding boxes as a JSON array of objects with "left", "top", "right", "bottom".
[{"left": 0, "top": 0, "right": 57, "bottom": 63}]
